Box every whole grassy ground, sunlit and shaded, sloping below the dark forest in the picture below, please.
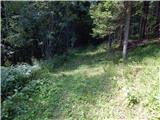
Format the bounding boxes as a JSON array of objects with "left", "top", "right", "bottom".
[{"left": 2, "top": 40, "right": 160, "bottom": 120}]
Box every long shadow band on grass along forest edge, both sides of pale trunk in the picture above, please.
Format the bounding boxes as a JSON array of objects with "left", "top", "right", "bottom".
[{"left": 45, "top": 44, "right": 160, "bottom": 73}]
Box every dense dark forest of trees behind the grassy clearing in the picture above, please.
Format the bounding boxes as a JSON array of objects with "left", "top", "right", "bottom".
[{"left": 1, "top": 1, "right": 160, "bottom": 65}]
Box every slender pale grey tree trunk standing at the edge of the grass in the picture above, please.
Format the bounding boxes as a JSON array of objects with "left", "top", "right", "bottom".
[{"left": 122, "top": 1, "right": 132, "bottom": 60}]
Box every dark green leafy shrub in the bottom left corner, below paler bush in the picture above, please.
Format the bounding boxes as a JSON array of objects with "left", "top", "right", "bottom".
[{"left": 1, "top": 79, "right": 42, "bottom": 120}]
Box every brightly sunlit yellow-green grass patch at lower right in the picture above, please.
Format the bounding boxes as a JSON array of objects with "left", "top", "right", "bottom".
[{"left": 83, "top": 63, "right": 160, "bottom": 120}]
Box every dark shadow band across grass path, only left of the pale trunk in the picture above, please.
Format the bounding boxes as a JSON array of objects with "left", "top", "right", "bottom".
[{"left": 48, "top": 51, "right": 120, "bottom": 73}]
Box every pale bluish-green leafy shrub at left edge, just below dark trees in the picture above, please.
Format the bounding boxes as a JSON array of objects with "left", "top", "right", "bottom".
[{"left": 1, "top": 64, "right": 38, "bottom": 100}]
